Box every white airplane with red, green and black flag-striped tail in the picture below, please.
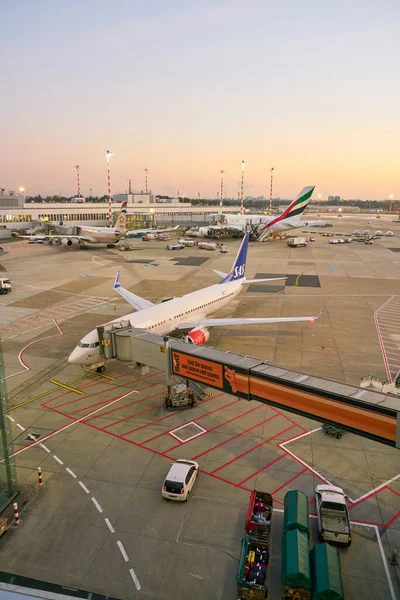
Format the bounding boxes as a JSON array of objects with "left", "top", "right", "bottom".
[{"left": 193, "top": 185, "right": 327, "bottom": 242}]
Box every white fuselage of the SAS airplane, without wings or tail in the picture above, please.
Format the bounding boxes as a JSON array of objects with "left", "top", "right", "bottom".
[{"left": 69, "top": 280, "right": 242, "bottom": 366}]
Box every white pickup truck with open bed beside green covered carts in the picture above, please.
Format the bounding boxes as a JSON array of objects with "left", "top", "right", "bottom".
[{"left": 315, "top": 484, "right": 351, "bottom": 546}]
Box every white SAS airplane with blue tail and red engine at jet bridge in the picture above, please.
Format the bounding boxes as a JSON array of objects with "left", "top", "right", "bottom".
[{"left": 68, "top": 233, "right": 323, "bottom": 371}]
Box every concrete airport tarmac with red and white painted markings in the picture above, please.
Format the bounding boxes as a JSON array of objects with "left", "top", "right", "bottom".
[{"left": 0, "top": 216, "right": 400, "bottom": 600}]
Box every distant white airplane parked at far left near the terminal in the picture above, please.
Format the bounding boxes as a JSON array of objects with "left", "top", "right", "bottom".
[{"left": 21, "top": 201, "right": 128, "bottom": 248}]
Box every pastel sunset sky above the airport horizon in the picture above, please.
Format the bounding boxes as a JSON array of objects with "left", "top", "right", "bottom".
[{"left": 0, "top": 0, "right": 400, "bottom": 198}]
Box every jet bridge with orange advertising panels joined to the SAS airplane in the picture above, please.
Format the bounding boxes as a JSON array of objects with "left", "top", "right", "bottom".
[{"left": 97, "top": 322, "right": 400, "bottom": 448}]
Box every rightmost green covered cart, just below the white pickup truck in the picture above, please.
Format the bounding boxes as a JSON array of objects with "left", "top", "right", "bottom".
[{"left": 311, "top": 543, "right": 344, "bottom": 600}]
